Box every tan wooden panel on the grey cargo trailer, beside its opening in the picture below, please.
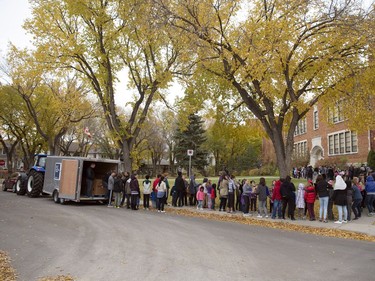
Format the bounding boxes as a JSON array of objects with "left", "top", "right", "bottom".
[{"left": 59, "top": 159, "right": 80, "bottom": 200}]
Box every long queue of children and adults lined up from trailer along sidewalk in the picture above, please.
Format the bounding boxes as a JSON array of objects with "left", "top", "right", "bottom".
[{"left": 107, "top": 168, "right": 375, "bottom": 223}]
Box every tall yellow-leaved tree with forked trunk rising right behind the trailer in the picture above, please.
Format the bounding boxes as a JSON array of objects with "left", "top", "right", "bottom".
[{"left": 25, "top": 0, "right": 189, "bottom": 171}]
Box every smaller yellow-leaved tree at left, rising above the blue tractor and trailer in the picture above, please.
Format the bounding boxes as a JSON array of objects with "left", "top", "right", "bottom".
[{"left": 7, "top": 46, "right": 94, "bottom": 155}]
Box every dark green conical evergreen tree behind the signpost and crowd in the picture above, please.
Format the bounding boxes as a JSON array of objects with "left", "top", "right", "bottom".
[{"left": 174, "top": 114, "right": 208, "bottom": 173}]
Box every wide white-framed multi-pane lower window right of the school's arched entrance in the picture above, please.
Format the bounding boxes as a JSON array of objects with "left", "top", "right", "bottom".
[{"left": 328, "top": 131, "right": 358, "bottom": 155}]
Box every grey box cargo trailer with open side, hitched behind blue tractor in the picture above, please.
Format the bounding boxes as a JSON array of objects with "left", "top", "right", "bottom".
[{"left": 43, "top": 156, "right": 121, "bottom": 203}]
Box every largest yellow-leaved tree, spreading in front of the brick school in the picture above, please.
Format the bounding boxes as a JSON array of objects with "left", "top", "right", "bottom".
[{"left": 154, "top": 0, "right": 371, "bottom": 177}]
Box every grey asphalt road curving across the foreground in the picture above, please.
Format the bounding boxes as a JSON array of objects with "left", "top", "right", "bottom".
[{"left": 0, "top": 192, "right": 375, "bottom": 281}]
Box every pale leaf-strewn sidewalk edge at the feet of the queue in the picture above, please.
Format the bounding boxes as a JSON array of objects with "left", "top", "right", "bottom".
[{"left": 167, "top": 206, "right": 375, "bottom": 237}]
